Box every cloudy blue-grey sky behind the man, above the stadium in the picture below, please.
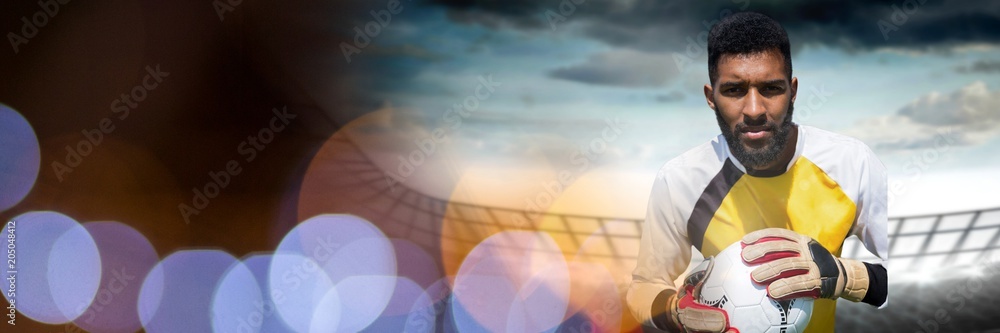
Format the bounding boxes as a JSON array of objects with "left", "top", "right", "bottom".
[{"left": 334, "top": 0, "right": 1000, "bottom": 215}]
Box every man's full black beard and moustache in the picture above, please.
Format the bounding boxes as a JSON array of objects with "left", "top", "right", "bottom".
[{"left": 715, "top": 101, "right": 795, "bottom": 170}]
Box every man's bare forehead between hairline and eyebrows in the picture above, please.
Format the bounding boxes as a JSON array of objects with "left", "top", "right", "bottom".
[{"left": 717, "top": 51, "right": 788, "bottom": 82}]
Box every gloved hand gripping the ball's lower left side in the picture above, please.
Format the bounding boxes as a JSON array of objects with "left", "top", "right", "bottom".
[{"left": 667, "top": 257, "right": 738, "bottom": 333}]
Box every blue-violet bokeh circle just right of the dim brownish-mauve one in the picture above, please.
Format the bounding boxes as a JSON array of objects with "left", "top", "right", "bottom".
[{"left": 138, "top": 250, "right": 238, "bottom": 333}]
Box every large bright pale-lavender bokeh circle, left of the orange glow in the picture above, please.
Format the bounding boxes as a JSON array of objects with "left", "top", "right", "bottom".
[{"left": 269, "top": 214, "right": 396, "bottom": 331}]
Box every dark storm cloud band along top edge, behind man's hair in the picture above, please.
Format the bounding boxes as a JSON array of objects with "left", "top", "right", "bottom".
[{"left": 431, "top": 0, "right": 1000, "bottom": 51}]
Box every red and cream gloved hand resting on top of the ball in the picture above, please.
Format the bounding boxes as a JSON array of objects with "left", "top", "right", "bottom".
[{"left": 741, "top": 228, "right": 868, "bottom": 302}]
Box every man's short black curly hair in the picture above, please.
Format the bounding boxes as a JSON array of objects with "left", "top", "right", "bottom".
[{"left": 708, "top": 12, "right": 792, "bottom": 86}]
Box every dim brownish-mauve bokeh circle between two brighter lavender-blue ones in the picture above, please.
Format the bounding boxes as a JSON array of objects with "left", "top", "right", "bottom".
[{"left": 73, "top": 222, "right": 159, "bottom": 333}]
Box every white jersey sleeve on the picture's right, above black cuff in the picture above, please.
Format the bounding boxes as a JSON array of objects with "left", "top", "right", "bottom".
[{"left": 853, "top": 144, "right": 889, "bottom": 308}]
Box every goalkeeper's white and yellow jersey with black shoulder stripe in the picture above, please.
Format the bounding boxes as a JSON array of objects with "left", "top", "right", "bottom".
[{"left": 626, "top": 125, "right": 889, "bottom": 333}]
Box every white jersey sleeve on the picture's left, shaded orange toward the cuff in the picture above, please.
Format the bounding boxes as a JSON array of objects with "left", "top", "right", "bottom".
[{"left": 626, "top": 171, "right": 691, "bottom": 329}]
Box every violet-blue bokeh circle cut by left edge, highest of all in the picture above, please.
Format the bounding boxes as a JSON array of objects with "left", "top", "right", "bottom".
[{"left": 0, "top": 104, "right": 42, "bottom": 211}]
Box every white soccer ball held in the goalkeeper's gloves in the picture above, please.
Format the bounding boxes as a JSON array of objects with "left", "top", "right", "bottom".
[{"left": 698, "top": 242, "right": 813, "bottom": 333}]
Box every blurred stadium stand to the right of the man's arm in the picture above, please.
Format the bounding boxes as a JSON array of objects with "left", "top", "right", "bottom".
[{"left": 837, "top": 208, "right": 1000, "bottom": 333}]
